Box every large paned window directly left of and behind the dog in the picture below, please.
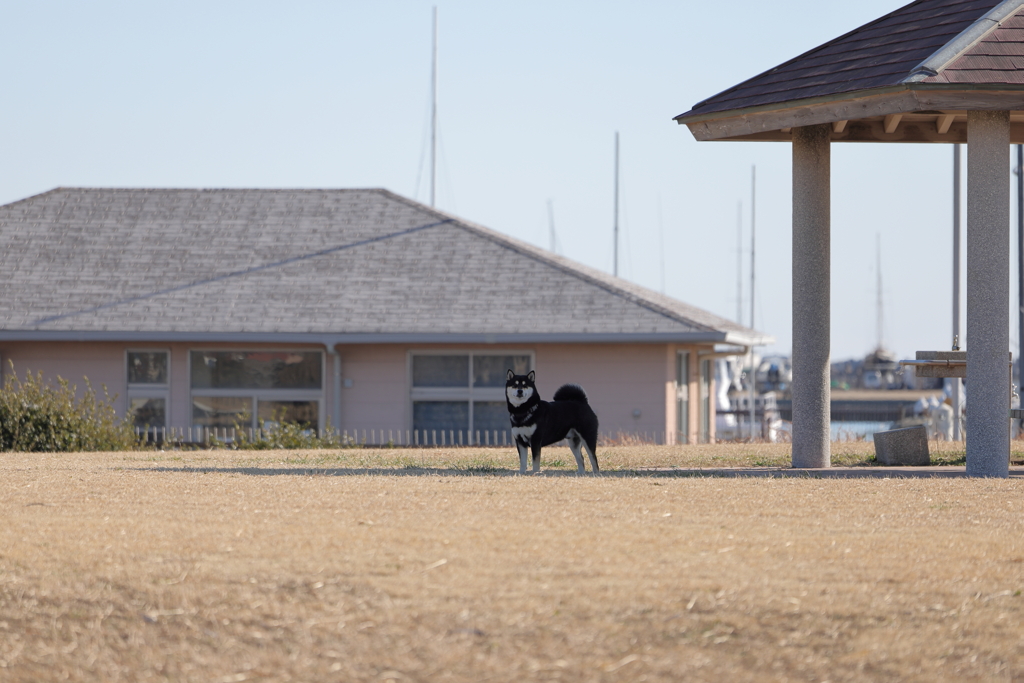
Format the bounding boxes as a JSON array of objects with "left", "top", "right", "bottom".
[{"left": 411, "top": 352, "right": 534, "bottom": 443}]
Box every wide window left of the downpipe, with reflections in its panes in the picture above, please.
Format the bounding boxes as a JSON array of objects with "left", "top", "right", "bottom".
[{"left": 188, "top": 350, "right": 325, "bottom": 429}]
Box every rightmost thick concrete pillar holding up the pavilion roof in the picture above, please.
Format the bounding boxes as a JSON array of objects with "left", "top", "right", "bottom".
[{"left": 966, "top": 112, "right": 1010, "bottom": 477}]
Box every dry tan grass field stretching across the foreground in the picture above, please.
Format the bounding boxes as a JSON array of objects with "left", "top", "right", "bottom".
[{"left": 0, "top": 443, "right": 1024, "bottom": 683}]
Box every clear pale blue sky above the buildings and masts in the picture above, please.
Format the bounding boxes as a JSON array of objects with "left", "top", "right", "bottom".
[{"left": 0, "top": 0, "right": 1017, "bottom": 359}]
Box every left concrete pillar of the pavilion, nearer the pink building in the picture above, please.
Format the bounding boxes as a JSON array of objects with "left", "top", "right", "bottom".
[{"left": 792, "top": 124, "right": 831, "bottom": 467}]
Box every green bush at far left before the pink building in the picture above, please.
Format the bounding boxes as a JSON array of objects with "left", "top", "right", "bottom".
[{"left": 0, "top": 362, "right": 139, "bottom": 452}]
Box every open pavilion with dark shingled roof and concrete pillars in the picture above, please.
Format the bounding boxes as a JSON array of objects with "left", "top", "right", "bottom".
[{"left": 676, "top": 0, "right": 1024, "bottom": 477}]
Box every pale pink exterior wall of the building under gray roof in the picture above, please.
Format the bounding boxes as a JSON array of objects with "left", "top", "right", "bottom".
[{"left": 0, "top": 342, "right": 715, "bottom": 442}]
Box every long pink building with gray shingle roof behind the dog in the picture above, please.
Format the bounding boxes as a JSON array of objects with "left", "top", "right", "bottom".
[{"left": 0, "top": 188, "right": 771, "bottom": 442}]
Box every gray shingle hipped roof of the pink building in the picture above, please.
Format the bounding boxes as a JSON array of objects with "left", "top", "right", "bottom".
[{"left": 0, "top": 188, "right": 770, "bottom": 343}]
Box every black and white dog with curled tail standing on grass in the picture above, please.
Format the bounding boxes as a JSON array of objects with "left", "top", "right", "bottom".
[{"left": 505, "top": 370, "right": 601, "bottom": 474}]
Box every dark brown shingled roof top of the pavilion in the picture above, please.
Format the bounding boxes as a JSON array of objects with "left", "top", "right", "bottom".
[{"left": 677, "top": 0, "right": 1011, "bottom": 123}]
